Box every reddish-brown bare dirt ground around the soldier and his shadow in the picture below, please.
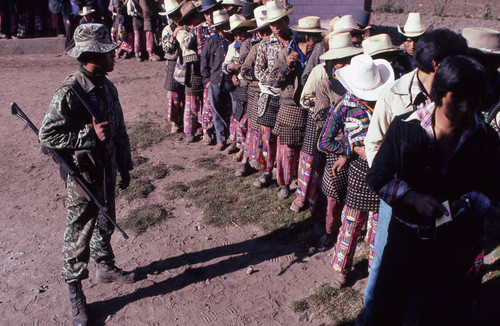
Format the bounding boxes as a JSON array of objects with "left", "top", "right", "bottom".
[{"left": 0, "top": 10, "right": 499, "bottom": 326}]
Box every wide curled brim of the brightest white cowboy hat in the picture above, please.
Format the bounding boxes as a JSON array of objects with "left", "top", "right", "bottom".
[{"left": 335, "top": 59, "right": 394, "bottom": 101}]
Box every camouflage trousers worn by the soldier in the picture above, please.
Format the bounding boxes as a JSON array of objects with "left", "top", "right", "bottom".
[{"left": 62, "top": 171, "right": 116, "bottom": 283}]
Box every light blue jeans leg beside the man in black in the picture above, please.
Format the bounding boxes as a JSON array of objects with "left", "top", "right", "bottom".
[{"left": 363, "top": 200, "right": 392, "bottom": 310}]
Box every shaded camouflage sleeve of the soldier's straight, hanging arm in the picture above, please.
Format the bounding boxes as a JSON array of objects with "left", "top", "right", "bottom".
[{"left": 113, "top": 86, "right": 134, "bottom": 171}]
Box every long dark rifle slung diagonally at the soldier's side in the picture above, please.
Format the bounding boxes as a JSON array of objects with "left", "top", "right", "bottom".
[{"left": 11, "top": 102, "right": 128, "bottom": 239}]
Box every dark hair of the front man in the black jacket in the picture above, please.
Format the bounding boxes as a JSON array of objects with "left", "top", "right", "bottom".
[{"left": 431, "top": 55, "right": 487, "bottom": 106}]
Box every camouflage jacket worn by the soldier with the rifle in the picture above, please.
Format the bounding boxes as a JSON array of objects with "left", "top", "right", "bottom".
[{"left": 39, "top": 67, "right": 133, "bottom": 171}]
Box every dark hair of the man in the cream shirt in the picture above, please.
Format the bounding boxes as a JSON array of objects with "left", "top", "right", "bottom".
[{"left": 413, "top": 28, "right": 468, "bottom": 73}]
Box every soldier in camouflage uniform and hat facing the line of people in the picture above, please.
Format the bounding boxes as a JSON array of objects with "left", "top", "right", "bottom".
[{"left": 39, "top": 24, "right": 135, "bottom": 325}]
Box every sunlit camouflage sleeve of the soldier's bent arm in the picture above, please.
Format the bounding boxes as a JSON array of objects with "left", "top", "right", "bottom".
[{"left": 38, "top": 87, "right": 97, "bottom": 150}]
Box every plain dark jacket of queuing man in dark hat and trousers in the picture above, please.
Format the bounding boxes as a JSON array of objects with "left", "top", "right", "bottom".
[{"left": 201, "top": 34, "right": 229, "bottom": 86}]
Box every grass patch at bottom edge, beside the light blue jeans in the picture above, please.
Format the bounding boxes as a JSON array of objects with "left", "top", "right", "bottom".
[{"left": 290, "top": 284, "right": 363, "bottom": 324}]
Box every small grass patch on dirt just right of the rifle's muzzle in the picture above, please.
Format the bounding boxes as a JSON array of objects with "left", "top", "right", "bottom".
[{"left": 120, "top": 204, "right": 173, "bottom": 234}]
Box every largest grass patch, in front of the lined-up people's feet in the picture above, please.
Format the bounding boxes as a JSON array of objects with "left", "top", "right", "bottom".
[{"left": 187, "top": 172, "right": 308, "bottom": 233}]
